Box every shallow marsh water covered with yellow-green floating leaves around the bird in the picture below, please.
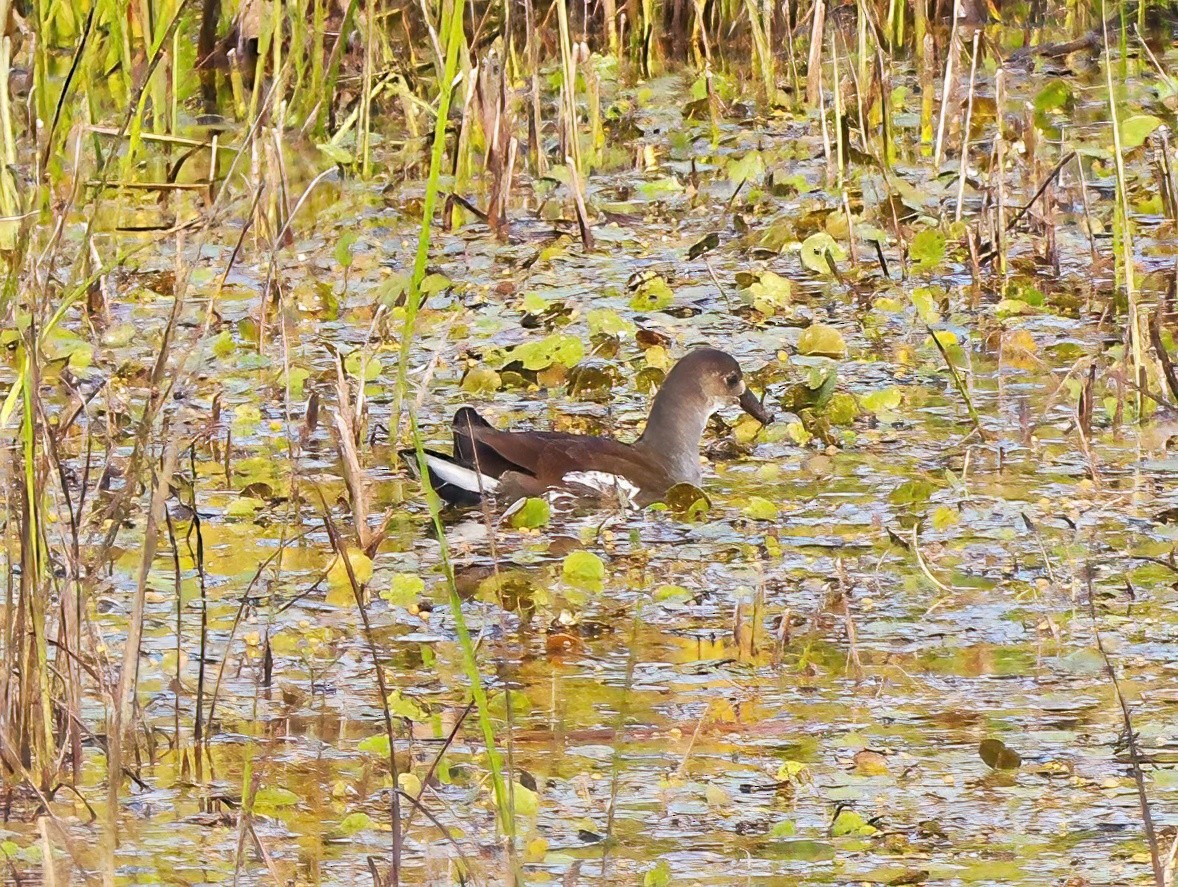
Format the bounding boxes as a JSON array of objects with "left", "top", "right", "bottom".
[{"left": 4, "top": 8, "right": 1178, "bottom": 886}]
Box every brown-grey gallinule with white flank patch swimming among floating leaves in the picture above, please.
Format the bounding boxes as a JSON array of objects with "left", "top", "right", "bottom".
[{"left": 401, "top": 347, "right": 772, "bottom": 505}]
